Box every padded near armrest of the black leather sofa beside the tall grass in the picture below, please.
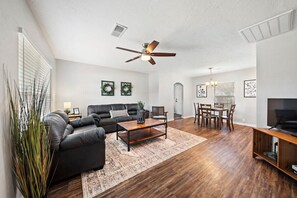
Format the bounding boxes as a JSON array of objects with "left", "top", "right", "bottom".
[{"left": 60, "top": 127, "right": 106, "bottom": 151}]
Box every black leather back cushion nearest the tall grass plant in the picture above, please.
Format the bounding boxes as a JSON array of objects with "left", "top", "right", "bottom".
[{"left": 44, "top": 112, "right": 67, "bottom": 150}]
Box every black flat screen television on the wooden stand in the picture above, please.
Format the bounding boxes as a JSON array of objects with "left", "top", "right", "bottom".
[{"left": 267, "top": 98, "right": 297, "bottom": 134}]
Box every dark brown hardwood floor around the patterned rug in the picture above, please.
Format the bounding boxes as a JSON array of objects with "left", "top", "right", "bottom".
[{"left": 48, "top": 118, "right": 297, "bottom": 198}]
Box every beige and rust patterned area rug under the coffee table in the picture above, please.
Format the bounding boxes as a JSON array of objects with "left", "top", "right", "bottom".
[{"left": 81, "top": 127, "right": 206, "bottom": 198}]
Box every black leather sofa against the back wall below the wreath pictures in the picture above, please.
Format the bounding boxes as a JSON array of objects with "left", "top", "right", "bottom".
[{"left": 88, "top": 103, "right": 149, "bottom": 133}]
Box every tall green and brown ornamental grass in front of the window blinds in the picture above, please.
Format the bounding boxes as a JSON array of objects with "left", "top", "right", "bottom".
[{"left": 7, "top": 74, "right": 52, "bottom": 198}]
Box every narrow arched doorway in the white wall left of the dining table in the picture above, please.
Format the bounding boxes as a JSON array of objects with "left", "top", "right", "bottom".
[{"left": 174, "top": 82, "right": 184, "bottom": 120}]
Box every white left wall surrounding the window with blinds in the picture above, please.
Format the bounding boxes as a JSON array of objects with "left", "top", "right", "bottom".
[{"left": 0, "top": 0, "right": 55, "bottom": 197}]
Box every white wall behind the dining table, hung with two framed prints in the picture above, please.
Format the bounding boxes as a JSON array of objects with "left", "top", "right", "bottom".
[{"left": 191, "top": 68, "right": 256, "bottom": 126}]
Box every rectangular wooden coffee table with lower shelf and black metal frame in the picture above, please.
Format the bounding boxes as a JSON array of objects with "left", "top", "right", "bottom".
[{"left": 117, "top": 118, "right": 167, "bottom": 151}]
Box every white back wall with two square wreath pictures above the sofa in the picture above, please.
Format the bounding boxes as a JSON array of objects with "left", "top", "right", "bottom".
[{"left": 56, "top": 60, "right": 149, "bottom": 115}]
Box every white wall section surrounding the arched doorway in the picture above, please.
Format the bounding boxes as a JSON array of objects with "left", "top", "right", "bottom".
[{"left": 149, "top": 70, "right": 192, "bottom": 120}]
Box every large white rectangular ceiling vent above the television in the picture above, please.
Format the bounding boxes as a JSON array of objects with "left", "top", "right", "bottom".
[{"left": 239, "top": 10, "right": 294, "bottom": 43}]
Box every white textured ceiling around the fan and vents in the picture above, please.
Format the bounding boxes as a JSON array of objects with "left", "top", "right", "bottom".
[{"left": 27, "top": 0, "right": 297, "bottom": 76}]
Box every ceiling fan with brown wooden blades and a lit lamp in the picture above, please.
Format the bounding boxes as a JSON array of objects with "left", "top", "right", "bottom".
[{"left": 116, "top": 41, "right": 176, "bottom": 65}]
